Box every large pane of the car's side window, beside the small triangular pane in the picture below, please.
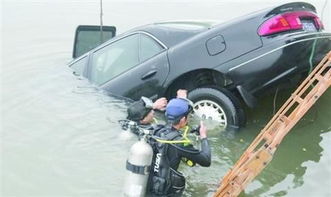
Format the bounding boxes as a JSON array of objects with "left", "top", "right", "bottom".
[{"left": 90, "top": 34, "right": 139, "bottom": 85}]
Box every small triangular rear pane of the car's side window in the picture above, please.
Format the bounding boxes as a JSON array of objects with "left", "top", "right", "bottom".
[{"left": 139, "top": 34, "right": 164, "bottom": 62}]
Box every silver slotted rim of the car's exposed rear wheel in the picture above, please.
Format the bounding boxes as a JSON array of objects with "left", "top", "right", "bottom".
[{"left": 193, "top": 100, "right": 227, "bottom": 127}]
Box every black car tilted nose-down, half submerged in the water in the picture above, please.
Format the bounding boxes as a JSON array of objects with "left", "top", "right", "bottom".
[{"left": 70, "top": 2, "right": 331, "bottom": 131}]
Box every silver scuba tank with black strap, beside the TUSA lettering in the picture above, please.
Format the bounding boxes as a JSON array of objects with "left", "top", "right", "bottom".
[{"left": 124, "top": 138, "right": 153, "bottom": 197}]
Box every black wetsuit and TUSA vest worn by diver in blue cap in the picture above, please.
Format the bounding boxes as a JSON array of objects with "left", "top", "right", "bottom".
[{"left": 148, "top": 127, "right": 211, "bottom": 196}]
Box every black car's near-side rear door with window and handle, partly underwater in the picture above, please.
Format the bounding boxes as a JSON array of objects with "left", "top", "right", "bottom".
[{"left": 89, "top": 32, "right": 169, "bottom": 100}]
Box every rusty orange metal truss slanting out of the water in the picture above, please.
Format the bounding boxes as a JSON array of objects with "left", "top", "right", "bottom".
[{"left": 214, "top": 51, "right": 331, "bottom": 197}]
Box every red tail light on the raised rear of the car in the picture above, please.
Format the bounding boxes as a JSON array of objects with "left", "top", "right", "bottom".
[{"left": 258, "top": 11, "right": 323, "bottom": 36}]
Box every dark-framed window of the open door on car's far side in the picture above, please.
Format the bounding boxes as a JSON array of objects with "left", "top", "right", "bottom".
[{"left": 72, "top": 25, "right": 116, "bottom": 58}]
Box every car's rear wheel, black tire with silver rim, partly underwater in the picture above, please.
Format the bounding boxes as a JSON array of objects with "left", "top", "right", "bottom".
[{"left": 188, "top": 88, "right": 246, "bottom": 130}]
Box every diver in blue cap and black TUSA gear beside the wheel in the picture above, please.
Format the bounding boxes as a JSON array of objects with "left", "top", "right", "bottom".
[{"left": 148, "top": 94, "right": 211, "bottom": 196}]
